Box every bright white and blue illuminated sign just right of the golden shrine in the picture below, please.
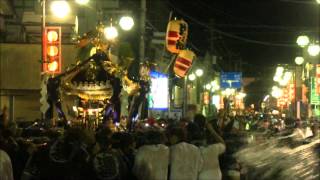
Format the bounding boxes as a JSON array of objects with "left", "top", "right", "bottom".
[{"left": 148, "top": 71, "right": 169, "bottom": 110}]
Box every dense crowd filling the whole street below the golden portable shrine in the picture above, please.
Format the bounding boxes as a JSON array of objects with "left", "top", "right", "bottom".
[{"left": 0, "top": 105, "right": 317, "bottom": 180}]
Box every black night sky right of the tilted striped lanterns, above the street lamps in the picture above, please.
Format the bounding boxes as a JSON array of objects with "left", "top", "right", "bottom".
[{"left": 169, "top": 0, "right": 320, "bottom": 68}]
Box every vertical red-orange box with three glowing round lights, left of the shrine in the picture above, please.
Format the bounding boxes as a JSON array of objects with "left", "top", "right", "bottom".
[{"left": 42, "top": 27, "right": 61, "bottom": 74}]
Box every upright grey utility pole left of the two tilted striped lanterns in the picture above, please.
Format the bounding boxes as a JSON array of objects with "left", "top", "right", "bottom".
[{"left": 139, "top": 0, "right": 147, "bottom": 61}]
